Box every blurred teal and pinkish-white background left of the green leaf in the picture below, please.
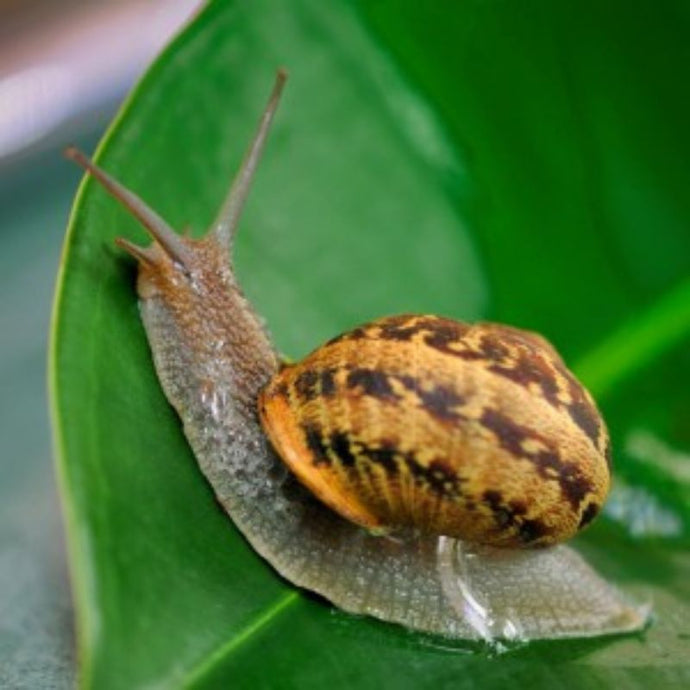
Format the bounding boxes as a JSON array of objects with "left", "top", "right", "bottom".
[{"left": 0, "top": 0, "right": 198, "bottom": 690}]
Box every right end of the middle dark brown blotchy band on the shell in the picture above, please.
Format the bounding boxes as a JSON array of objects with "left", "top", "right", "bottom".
[{"left": 480, "top": 408, "right": 593, "bottom": 510}]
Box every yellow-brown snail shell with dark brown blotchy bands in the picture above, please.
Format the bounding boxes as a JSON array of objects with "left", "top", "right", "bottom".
[{"left": 259, "top": 315, "right": 610, "bottom": 547}]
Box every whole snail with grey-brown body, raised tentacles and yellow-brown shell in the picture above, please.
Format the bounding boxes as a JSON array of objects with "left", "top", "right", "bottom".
[{"left": 66, "top": 70, "right": 646, "bottom": 642}]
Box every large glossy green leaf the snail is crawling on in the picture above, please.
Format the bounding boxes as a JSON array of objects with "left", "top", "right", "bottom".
[{"left": 51, "top": 0, "right": 690, "bottom": 688}]
